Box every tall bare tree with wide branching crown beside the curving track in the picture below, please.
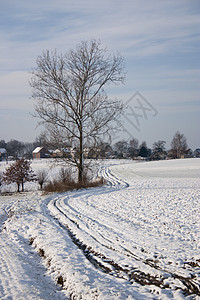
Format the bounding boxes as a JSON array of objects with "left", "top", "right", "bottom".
[{"left": 30, "top": 40, "right": 125, "bottom": 184}]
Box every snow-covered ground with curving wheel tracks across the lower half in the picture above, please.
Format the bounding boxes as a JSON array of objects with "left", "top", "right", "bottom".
[{"left": 0, "top": 159, "right": 200, "bottom": 300}]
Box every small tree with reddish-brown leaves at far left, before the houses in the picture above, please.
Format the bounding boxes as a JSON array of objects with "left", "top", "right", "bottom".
[{"left": 3, "top": 158, "right": 36, "bottom": 192}]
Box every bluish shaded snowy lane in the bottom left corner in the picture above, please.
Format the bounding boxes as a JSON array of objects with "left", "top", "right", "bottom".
[{"left": 0, "top": 205, "right": 67, "bottom": 300}]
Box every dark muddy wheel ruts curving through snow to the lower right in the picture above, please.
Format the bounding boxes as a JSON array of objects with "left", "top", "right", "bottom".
[{"left": 50, "top": 200, "right": 200, "bottom": 295}]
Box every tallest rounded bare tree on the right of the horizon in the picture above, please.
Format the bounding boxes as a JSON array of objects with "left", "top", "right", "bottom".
[{"left": 171, "top": 131, "right": 188, "bottom": 158}]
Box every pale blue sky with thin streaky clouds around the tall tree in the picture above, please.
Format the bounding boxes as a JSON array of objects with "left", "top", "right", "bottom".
[{"left": 0, "top": 0, "right": 200, "bottom": 150}]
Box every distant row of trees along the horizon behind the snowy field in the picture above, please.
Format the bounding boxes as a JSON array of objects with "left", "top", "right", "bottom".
[{"left": 0, "top": 131, "right": 192, "bottom": 160}]
